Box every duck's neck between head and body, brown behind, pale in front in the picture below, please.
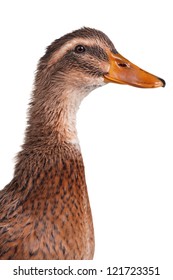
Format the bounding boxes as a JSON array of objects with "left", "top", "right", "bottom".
[{"left": 25, "top": 86, "right": 89, "bottom": 149}]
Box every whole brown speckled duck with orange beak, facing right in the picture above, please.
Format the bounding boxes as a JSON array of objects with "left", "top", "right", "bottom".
[{"left": 0, "top": 27, "right": 165, "bottom": 260}]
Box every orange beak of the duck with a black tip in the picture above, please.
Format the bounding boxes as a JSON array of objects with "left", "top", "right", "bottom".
[{"left": 104, "top": 52, "right": 165, "bottom": 88}]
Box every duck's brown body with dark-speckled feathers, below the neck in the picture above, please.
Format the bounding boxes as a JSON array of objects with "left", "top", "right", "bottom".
[{"left": 0, "top": 135, "right": 94, "bottom": 259}]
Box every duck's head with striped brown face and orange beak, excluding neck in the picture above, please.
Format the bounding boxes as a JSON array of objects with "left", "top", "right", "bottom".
[{"left": 40, "top": 28, "right": 165, "bottom": 91}]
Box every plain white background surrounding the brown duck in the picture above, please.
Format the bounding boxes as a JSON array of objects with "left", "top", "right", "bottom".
[{"left": 0, "top": 0, "right": 173, "bottom": 280}]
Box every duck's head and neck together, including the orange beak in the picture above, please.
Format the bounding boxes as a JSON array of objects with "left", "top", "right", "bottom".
[{"left": 27, "top": 28, "right": 165, "bottom": 144}]
